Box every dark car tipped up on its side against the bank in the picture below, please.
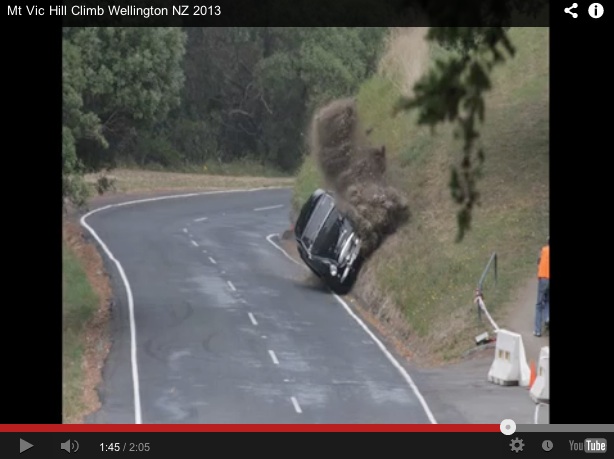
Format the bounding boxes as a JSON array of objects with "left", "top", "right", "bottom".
[{"left": 294, "top": 189, "right": 361, "bottom": 293}]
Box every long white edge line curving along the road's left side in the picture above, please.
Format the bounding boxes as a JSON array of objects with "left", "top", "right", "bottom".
[{"left": 80, "top": 187, "right": 288, "bottom": 424}]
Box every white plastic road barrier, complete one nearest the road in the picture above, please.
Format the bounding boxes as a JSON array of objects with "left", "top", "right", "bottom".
[{"left": 488, "top": 329, "right": 531, "bottom": 387}]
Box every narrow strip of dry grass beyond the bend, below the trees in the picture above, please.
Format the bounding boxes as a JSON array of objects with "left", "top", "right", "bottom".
[{"left": 85, "top": 169, "right": 294, "bottom": 197}]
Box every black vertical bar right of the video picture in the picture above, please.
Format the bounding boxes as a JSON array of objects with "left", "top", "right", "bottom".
[{"left": 550, "top": 4, "right": 612, "bottom": 424}]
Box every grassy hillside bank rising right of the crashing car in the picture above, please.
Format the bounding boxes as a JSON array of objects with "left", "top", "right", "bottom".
[{"left": 294, "top": 28, "right": 549, "bottom": 360}]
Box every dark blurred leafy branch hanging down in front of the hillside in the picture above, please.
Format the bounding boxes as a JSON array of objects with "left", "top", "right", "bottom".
[{"left": 394, "top": 27, "right": 515, "bottom": 241}]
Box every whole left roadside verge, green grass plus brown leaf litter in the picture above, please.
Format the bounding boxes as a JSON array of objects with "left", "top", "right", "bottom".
[{"left": 62, "top": 221, "right": 112, "bottom": 424}]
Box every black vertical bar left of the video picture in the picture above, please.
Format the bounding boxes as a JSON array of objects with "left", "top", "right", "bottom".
[{"left": 0, "top": 18, "right": 62, "bottom": 424}]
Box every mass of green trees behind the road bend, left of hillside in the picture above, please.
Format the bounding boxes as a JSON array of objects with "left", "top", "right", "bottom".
[{"left": 63, "top": 27, "right": 386, "bottom": 208}]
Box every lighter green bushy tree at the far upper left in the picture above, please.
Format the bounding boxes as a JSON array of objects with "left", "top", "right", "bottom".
[{"left": 62, "top": 27, "right": 185, "bottom": 205}]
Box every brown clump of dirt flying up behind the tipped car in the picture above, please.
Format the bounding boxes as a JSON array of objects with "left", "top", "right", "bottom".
[{"left": 309, "top": 98, "right": 410, "bottom": 258}]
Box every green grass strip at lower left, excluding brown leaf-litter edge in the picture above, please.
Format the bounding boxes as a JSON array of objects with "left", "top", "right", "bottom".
[{"left": 62, "top": 244, "right": 98, "bottom": 422}]
